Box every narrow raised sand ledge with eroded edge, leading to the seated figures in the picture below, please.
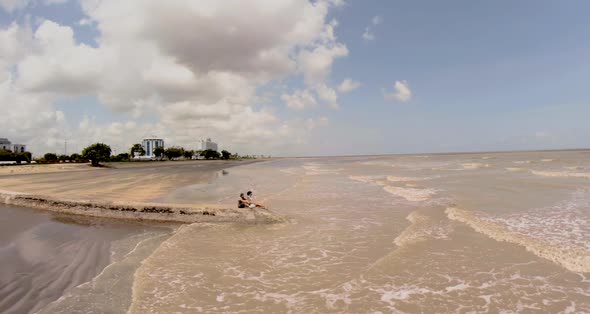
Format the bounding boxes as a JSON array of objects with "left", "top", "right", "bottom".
[{"left": 0, "top": 190, "right": 287, "bottom": 224}]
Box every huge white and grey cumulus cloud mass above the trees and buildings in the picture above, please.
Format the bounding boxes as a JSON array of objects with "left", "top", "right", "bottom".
[{"left": 0, "top": 0, "right": 348, "bottom": 152}]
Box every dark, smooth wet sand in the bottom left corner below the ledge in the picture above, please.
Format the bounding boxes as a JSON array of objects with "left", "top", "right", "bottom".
[{"left": 0, "top": 206, "right": 173, "bottom": 314}]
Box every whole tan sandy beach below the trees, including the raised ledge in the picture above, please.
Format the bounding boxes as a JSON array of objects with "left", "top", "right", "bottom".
[{"left": 0, "top": 161, "right": 281, "bottom": 223}]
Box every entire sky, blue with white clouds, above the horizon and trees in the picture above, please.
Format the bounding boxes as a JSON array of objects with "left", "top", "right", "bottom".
[{"left": 0, "top": 0, "right": 590, "bottom": 156}]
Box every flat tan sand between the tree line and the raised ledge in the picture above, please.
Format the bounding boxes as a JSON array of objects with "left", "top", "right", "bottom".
[{"left": 0, "top": 160, "right": 260, "bottom": 202}]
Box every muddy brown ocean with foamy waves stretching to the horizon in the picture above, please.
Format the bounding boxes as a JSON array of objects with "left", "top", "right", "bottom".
[{"left": 1, "top": 151, "right": 590, "bottom": 313}]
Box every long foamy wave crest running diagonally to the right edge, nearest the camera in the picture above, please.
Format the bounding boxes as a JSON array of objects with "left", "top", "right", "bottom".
[{"left": 445, "top": 207, "right": 590, "bottom": 273}]
